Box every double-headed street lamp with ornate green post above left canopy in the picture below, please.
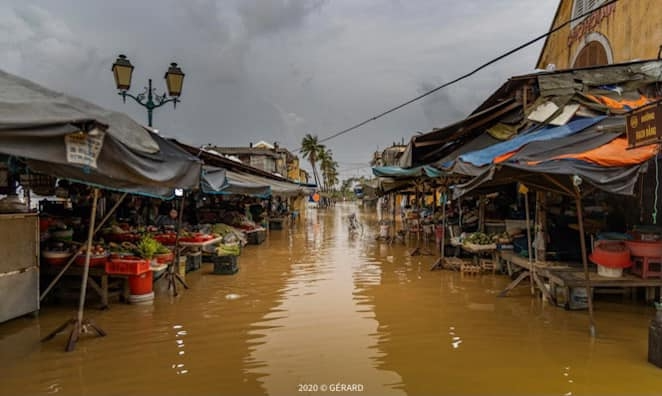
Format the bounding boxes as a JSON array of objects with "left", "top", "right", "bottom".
[{"left": 112, "top": 55, "right": 184, "bottom": 127}]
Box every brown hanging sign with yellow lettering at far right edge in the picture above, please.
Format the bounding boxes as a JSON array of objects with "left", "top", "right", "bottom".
[{"left": 625, "top": 103, "right": 662, "bottom": 148}]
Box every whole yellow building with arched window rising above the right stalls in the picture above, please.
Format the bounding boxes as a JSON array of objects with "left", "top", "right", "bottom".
[{"left": 536, "top": 0, "right": 662, "bottom": 69}]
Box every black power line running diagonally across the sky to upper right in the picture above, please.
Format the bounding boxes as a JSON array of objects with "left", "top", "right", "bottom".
[{"left": 293, "top": 0, "right": 618, "bottom": 152}]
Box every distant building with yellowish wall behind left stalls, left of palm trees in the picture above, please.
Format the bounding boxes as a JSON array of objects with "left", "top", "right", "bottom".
[{"left": 210, "top": 141, "right": 308, "bottom": 183}]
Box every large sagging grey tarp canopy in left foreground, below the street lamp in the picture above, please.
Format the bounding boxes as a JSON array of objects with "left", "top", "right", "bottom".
[{"left": 0, "top": 71, "right": 201, "bottom": 198}]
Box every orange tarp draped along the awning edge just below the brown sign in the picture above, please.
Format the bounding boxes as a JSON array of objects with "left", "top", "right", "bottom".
[{"left": 530, "top": 137, "right": 659, "bottom": 167}]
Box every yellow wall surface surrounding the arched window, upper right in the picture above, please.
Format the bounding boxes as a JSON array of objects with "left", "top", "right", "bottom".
[{"left": 536, "top": 0, "right": 662, "bottom": 69}]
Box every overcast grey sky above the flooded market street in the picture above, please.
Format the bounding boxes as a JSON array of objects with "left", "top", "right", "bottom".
[{"left": 0, "top": 0, "right": 558, "bottom": 178}]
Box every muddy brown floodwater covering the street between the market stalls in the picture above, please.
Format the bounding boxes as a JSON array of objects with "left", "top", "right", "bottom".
[{"left": 0, "top": 204, "right": 662, "bottom": 395}]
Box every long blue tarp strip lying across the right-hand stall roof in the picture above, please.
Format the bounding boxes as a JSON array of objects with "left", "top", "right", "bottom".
[{"left": 454, "top": 116, "right": 605, "bottom": 168}]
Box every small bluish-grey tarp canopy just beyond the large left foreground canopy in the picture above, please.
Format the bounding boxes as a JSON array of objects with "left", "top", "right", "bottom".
[{"left": 200, "top": 165, "right": 271, "bottom": 198}]
